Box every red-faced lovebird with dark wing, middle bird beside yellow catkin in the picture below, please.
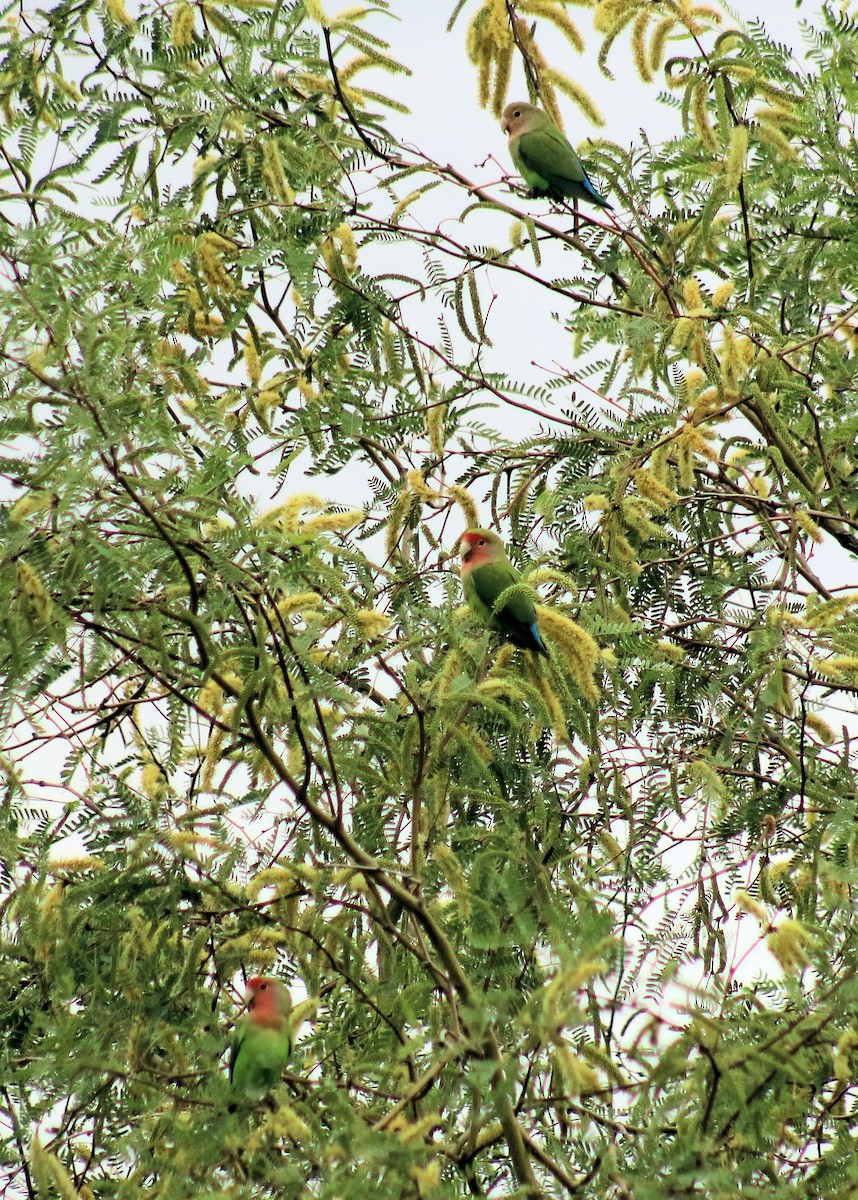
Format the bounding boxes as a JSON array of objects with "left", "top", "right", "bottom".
[{"left": 460, "top": 529, "right": 548, "bottom": 658}]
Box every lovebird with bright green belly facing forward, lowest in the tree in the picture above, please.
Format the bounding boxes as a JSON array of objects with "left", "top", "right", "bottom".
[{"left": 229, "top": 976, "right": 292, "bottom": 1093}]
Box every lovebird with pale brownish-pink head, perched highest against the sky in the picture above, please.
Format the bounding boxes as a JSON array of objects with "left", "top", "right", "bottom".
[{"left": 500, "top": 101, "right": 613, "bottom": 209}]
